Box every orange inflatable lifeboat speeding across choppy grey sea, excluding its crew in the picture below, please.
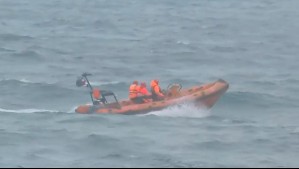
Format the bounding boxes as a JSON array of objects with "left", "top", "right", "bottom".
[{"left": 75, "top": 73, "right": 229, "bottom": 114}]
